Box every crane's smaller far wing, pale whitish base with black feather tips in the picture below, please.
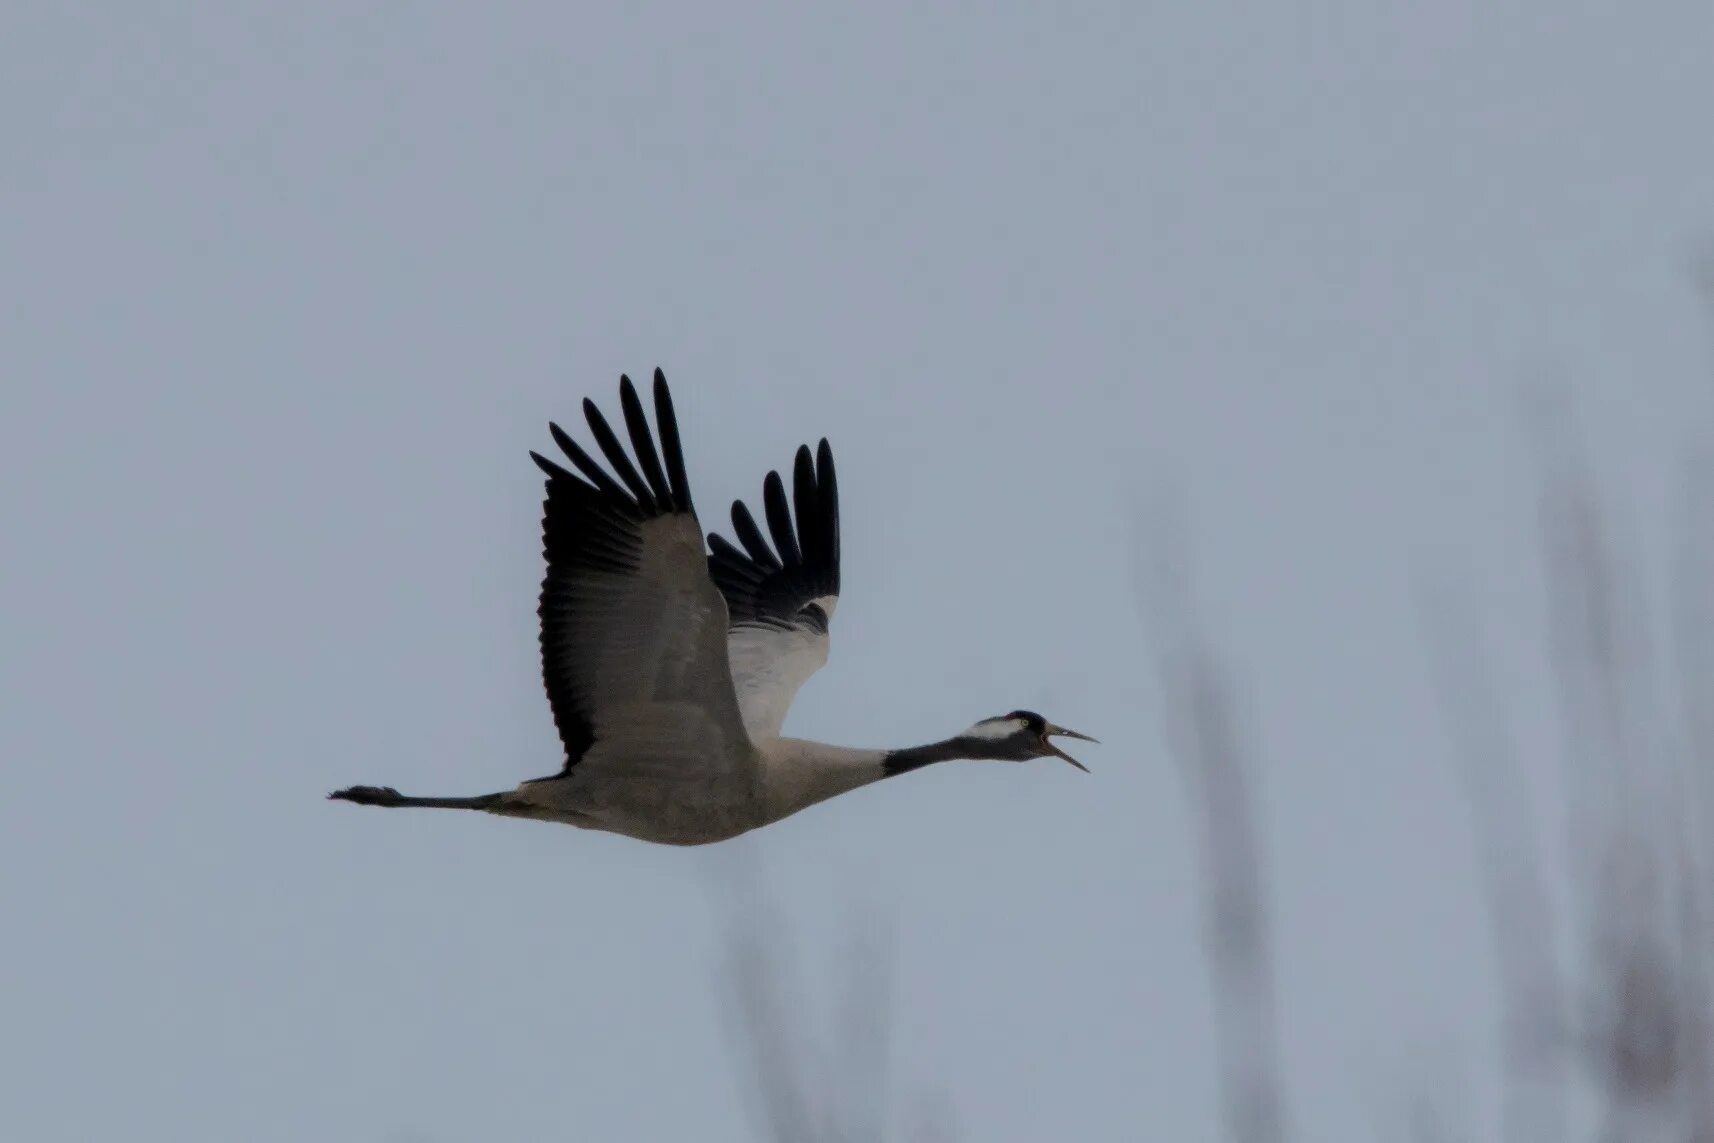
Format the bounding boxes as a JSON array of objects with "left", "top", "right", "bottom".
[{"left": 708, "top": 440, "right": 840, "bottom": 739}]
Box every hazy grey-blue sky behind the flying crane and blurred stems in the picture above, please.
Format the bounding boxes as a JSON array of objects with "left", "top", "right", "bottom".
[{"left": 0, "top": 0, "right": 1714, "bottom": 1143}]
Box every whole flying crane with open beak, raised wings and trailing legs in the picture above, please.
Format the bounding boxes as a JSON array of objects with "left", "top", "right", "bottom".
[{"left": 329, "top": 370, "right": 1092, "bottom": 845}]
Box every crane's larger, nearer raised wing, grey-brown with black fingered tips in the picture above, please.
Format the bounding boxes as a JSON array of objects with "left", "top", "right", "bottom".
[{"left": 530, "top": 370, "right": 752, "bottom": 780}]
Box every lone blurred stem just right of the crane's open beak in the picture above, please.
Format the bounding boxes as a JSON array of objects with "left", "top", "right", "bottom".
[{"left": 1138, "top": 514, "right": 1286, "bottom": 1143}]
